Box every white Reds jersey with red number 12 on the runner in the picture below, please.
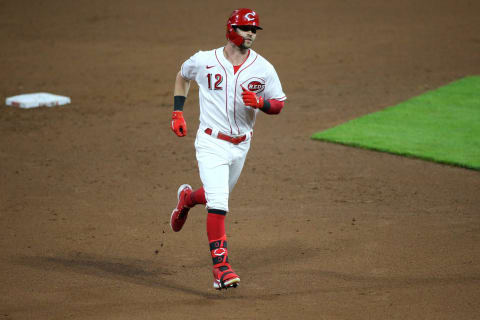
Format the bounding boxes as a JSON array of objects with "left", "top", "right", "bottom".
[{"left": 181, "top": 47, "right": 287, "bottom": 135}]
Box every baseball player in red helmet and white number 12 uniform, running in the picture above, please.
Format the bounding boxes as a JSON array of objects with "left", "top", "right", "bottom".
[{"left": 170, "top": 8, "right": 286, "bottom": 290}]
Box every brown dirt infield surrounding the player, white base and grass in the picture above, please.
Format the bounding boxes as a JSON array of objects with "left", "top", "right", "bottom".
[{"left": 0, "top": 0, "right": 480, "bottom": 320}]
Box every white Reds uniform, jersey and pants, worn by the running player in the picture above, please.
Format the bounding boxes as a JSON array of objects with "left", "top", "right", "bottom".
[{"left": 181, "top": 47, "right": 286, "bottom": 211}]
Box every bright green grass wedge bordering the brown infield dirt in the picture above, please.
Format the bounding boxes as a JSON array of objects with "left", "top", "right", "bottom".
[{"left": 312, "top": 76, "right": 480, "bottom": 170}]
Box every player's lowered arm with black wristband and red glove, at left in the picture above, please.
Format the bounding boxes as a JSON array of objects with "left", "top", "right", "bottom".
[{"left": 171, "top": 71, "right": 190, "bottom": 137}]
